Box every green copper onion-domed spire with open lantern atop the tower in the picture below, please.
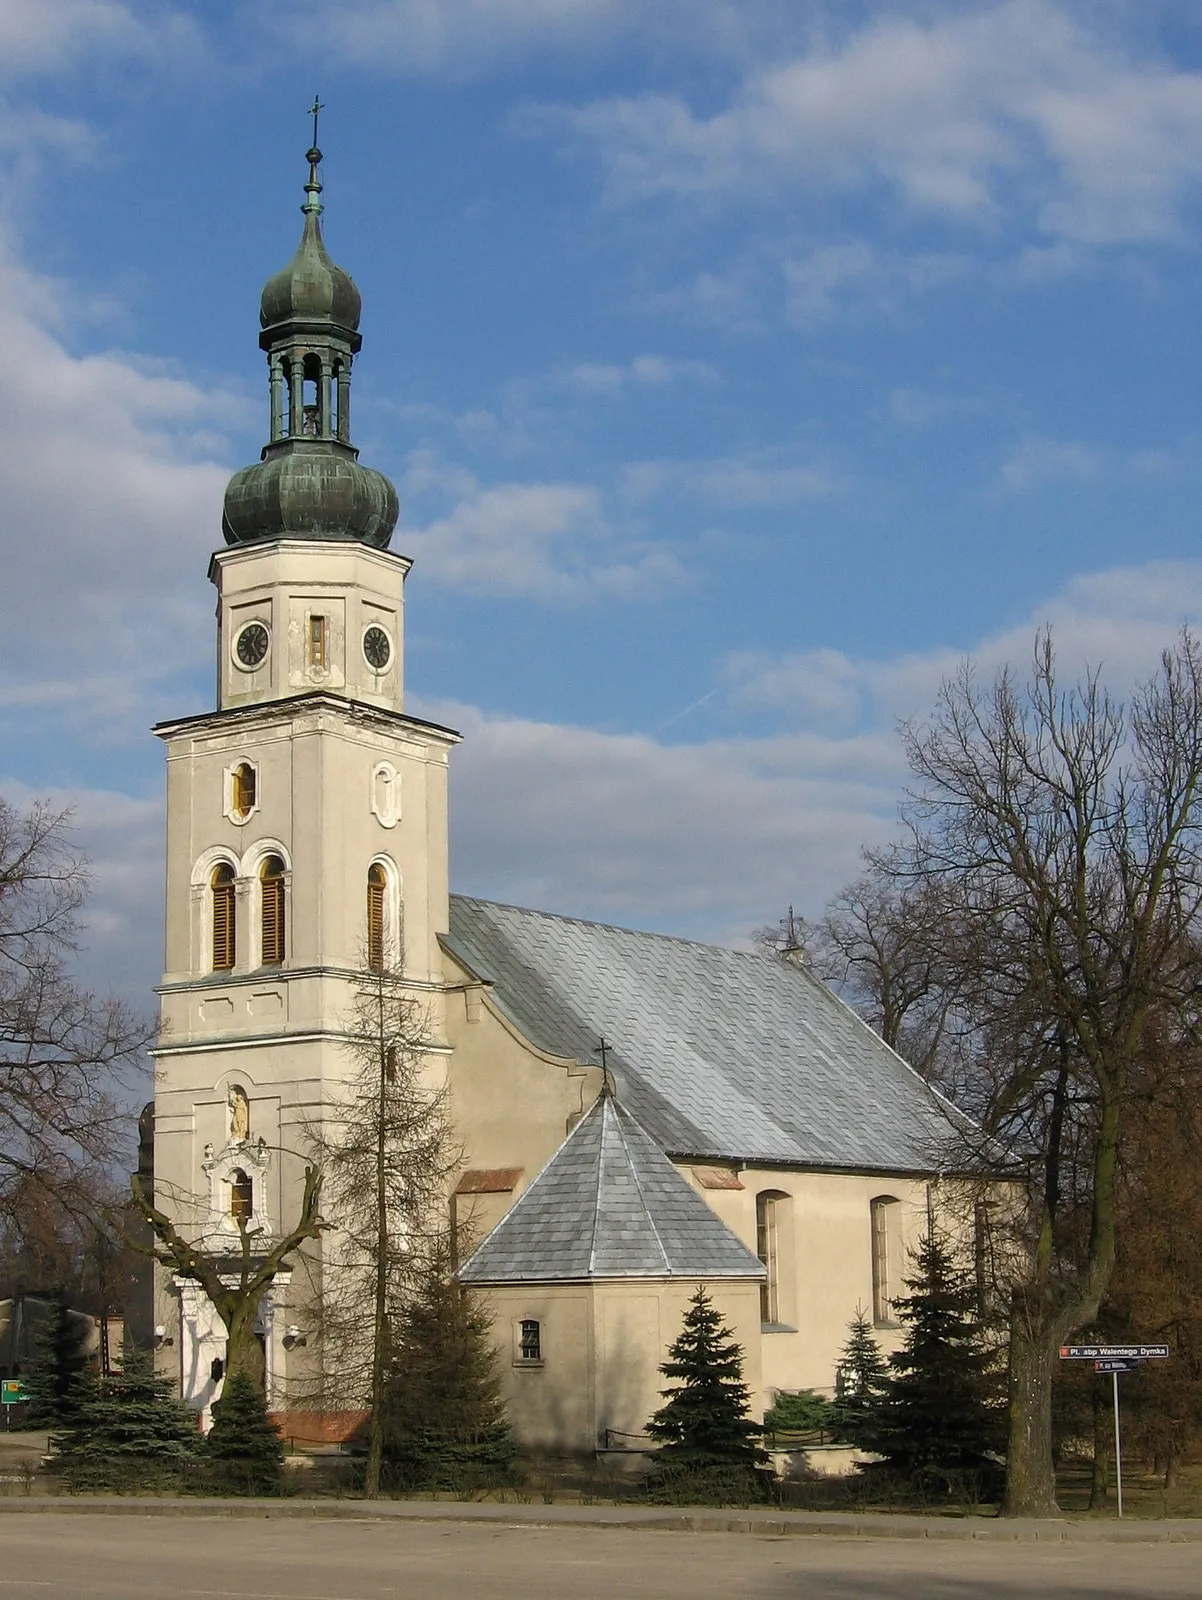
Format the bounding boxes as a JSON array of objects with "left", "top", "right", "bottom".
[{"left": 222, "top": 118, "right": 399, "bottom": 550}]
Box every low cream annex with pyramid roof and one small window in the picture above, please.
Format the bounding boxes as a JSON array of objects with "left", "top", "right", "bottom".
[{"left": 459, "top": 1088, "right": 765, "bottom": 1454}]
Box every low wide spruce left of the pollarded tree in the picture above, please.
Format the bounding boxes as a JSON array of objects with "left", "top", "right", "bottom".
[{"left": 50, "top": 1350, "right": 198, "bottom": 1491}]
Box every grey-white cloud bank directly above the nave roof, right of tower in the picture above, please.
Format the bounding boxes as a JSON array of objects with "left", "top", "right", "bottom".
[{"left": 429, "top": 706, "right": 899, "bottom": 939}]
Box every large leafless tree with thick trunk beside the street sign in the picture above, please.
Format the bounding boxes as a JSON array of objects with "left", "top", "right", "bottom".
[{"left": 891, "top": 634, "right": 1202, "bottom": 1515}]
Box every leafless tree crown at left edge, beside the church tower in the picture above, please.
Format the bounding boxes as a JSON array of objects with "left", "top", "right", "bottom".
[{"left": 0, "top": 798, "right": 152, "bottom": 1258}]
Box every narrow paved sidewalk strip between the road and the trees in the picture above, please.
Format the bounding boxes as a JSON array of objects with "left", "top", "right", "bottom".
[{"left": 0, "top": 1494, "right": 1202, "bottom": 1544}]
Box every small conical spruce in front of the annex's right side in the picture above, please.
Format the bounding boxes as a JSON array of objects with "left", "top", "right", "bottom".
[{"left": 647, "top": 1288, "right": 768, "bottom": 1501}]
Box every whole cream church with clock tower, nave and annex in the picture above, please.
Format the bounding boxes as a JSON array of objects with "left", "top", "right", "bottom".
[{"left": 154, "top": 147, "right": 949, "bottom": 1456}]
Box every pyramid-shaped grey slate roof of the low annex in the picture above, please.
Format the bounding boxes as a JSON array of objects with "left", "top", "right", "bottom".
[{"left": 459, "top": 1094, "right": 763, "bottom": 1283}]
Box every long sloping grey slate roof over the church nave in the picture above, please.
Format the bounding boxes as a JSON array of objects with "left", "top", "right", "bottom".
[{"left": 447, "top": 894, "right": 956, "bottom": 1173}]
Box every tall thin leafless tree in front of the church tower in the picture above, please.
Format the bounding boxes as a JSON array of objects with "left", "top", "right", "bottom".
[{"left": 311, "top": 965, "right": 458, "bottom": 1496}]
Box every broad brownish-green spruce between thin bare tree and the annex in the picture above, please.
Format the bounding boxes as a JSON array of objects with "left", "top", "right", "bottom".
[{"left": 381, "top": 1246, "right": 514, "bottom": 1490}]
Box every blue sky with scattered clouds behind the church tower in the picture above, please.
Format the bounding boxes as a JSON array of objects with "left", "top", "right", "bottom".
[{"left": 0, "top": 0, "right": 1202, "bottom": 995}]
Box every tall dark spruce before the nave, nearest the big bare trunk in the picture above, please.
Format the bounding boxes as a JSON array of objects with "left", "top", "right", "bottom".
[{"left": 861, "top": 1230, "right": 999, "bottom": 1486}]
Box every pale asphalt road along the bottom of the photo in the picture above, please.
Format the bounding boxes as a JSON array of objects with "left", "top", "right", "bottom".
[{"left": 0, "top": 1514, "right": 1202, "bottom": 1600}]
